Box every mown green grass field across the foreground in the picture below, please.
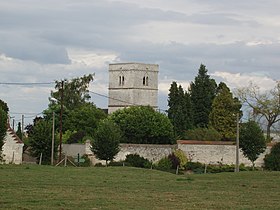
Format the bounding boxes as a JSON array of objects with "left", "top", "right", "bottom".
[{"left": 0, "top": 165, "right": 280, "bottom": 210}]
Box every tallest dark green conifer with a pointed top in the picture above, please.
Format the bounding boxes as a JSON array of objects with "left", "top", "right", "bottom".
[{"left": 189, "top": 64, "right": 217, "bottom": 127}]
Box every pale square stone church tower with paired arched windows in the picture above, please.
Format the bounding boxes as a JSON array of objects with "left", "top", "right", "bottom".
[{"left": 108, "top": 63, "right": 159, "bottom": 114}]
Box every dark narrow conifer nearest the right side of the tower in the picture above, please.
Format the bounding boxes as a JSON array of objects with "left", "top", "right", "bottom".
[{"left": 167, "top": 82, "right": 192, "bottom": 138}]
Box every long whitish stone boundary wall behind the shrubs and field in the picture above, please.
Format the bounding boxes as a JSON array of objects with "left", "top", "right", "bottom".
[{"left": 62, "top": 140, "right": 272, "bottom": 167}]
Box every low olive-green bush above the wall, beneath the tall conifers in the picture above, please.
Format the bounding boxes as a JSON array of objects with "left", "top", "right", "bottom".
[{"left": 186, "top": 128, "right": 222, "bottom": 141}]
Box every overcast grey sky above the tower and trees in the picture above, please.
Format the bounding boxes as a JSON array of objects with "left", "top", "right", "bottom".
[{"left": 0, "top": 0, "right": 280, "bottom": 124}]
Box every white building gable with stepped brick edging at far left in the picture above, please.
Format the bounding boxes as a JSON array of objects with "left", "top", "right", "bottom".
[{"left": 2, "top": 127, "right": 24, "bottom": 164}]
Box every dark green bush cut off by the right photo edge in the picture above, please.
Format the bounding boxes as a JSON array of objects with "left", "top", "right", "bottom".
[{"left": 264, "top": 143, "right": 280, "bottom": 171}]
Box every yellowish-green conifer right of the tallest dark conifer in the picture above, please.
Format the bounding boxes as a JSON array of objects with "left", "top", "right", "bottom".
[{"left": 209, "top": 82, "right": 242, "bottom": 140}]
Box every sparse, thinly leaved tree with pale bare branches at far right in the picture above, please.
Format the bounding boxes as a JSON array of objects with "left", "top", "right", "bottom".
[{"left": 237, "top": 81, "right": 280, "bottom": 141}]
